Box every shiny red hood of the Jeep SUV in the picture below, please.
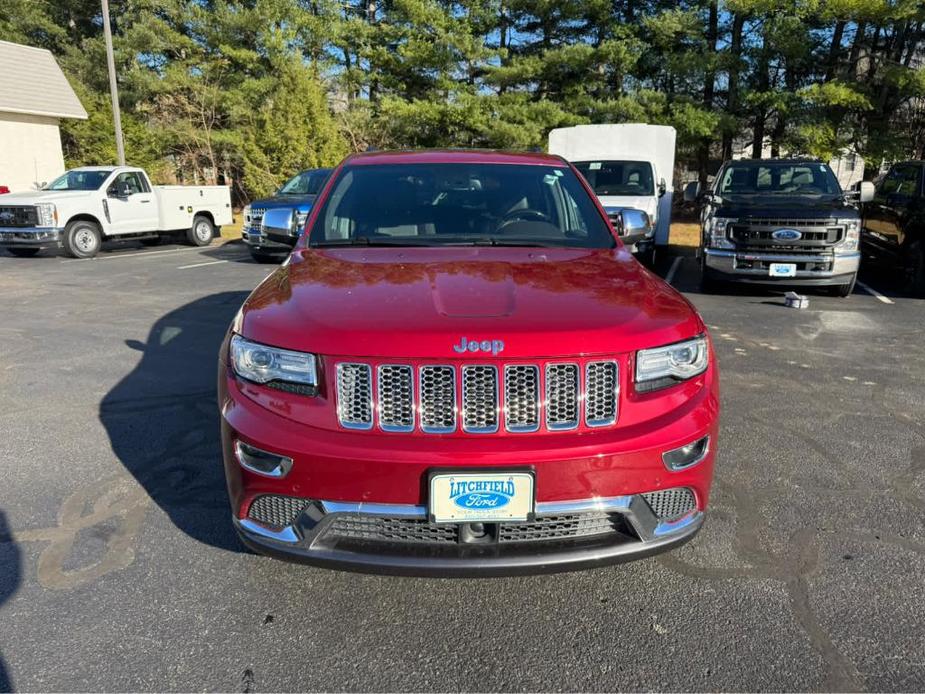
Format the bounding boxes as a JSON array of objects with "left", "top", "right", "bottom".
[{"left": 235, "top": 247, "right": 703, "bottom": 359}]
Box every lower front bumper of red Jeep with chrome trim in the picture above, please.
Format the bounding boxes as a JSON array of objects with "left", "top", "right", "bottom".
[{"left": 234, "top": 495, "right": 704, "bottom": 577}]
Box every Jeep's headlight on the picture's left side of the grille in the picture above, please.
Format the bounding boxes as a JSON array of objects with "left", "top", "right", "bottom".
[{"left": 231, "top": 335, "right": 318, "bottom": 395}]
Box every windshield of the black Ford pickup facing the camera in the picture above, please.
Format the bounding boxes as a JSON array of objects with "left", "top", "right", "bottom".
[{"left": 716, "top": 162, "right": 841, "bottom": 196}]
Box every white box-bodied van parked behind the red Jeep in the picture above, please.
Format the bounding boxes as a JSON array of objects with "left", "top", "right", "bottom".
[{"left": 549, "top": 123, "right": 677, "bottom": 261}]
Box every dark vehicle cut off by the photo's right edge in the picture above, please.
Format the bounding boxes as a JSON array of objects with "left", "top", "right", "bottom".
[{"left": 861, "top": 161, "right": 925, "bottom": 298}]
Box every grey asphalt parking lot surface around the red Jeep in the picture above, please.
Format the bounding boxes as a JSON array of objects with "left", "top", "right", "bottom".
[{"left": 0, "top": 244, "right": 925, "bottom": 691}]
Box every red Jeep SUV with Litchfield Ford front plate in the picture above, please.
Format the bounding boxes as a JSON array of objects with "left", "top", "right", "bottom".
[{"left": 218, "top": 151, "right": 719, "bottom": 576}]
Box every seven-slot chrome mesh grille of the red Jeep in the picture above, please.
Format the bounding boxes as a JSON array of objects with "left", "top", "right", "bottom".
[{"left": 335, "top": 359, "right": 620, "bottom": 434}]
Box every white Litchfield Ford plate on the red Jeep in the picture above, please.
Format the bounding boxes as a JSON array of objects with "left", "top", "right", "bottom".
[{"left": 430, "top": 472, "right": 533, "bottom": 523}]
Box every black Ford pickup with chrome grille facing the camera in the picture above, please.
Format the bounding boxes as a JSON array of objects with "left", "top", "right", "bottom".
[{"left": 684, "top": 159, "right": 873, "bottom": 296}]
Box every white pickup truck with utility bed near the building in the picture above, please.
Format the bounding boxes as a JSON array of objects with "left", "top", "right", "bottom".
[{"left": 0, "top": 166, "right": 232, "bottom": 258}]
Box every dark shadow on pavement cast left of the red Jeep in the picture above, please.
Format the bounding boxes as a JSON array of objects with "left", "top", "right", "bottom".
[{"left": 100, "top": 292, "right": 247, "bottom": 551}]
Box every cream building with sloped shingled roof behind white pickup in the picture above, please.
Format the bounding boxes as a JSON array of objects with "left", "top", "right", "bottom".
[{"left": 0, "top": 41, "right": 87, "bottom": 192}]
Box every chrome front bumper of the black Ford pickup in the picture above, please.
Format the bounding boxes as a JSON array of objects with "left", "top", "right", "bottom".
[{"left": 702, "top": 248, "right": 861, "bottom": 286}]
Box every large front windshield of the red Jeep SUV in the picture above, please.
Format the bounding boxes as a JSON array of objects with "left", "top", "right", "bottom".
[{"left": 309, "top": 164, "right": 614, "bottom": 248}]
